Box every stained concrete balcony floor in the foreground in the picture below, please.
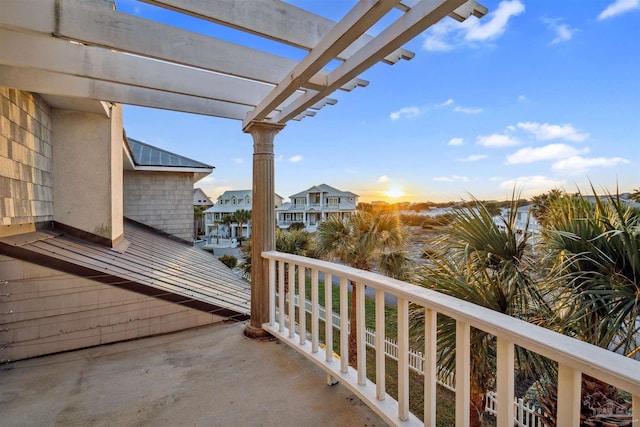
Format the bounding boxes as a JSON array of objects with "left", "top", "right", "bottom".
[{"left": 0, "top": 323, "right": 386, "bottom": 426}]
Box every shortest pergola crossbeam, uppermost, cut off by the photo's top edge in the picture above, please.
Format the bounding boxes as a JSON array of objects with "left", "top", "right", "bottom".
[{"left": 141, "top": 0, "right": 415, "bottom": 64}]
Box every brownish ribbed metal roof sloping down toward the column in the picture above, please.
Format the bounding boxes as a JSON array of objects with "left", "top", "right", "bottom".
[{"left": 0, "top": 220, "right": 250, "bottom": 320}]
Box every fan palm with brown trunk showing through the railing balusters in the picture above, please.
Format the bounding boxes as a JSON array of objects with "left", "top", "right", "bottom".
[{"left": 410, "top": 194, "right": 546, "bottom": 426}]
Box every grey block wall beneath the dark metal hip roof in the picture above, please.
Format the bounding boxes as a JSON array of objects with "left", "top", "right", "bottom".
[{"left": 124, "top": 171, "right": 194, "bottom": 241}]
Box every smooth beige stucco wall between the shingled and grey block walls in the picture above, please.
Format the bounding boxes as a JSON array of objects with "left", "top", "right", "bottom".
[{"left": 52, "top": 105, "right": 123, "bottom": 241}]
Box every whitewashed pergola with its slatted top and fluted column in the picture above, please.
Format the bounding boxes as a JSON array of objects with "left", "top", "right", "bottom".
[{"left": 0, "top": 0, "right": 487, "bottom": 338}]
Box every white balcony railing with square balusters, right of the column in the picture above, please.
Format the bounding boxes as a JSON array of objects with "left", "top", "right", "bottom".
[{"left": 262, "top": 252, "right": 640, "bottom": 427}]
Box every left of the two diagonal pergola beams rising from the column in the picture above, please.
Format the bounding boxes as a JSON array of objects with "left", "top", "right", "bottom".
[{"left": 242, "top": 0, "right": 398, "bottom": 128}]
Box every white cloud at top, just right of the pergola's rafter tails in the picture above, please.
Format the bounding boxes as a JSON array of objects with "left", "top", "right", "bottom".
[{"left": 422, "top": 0, "right": 524, "bottom": 51}]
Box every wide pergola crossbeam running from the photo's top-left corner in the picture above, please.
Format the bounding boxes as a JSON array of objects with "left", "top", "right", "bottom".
[{"left": 0, "top": 0, "right": 362, "bottom": 90}]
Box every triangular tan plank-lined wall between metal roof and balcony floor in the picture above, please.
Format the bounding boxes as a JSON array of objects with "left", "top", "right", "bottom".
[{"left": 0, "top": 255, "right": 222, "bottom": 362}]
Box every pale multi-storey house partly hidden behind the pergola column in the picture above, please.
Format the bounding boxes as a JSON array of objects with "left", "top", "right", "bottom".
[{"left": 204, "top": 190, "right": 283, "bottom": 239}]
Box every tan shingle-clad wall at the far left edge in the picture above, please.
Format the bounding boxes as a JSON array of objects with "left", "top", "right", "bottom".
[{"left": 0, "top": 87, "right": 53, "bottom": 227}]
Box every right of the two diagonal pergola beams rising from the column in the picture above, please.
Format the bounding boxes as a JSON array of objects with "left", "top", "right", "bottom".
[{"left": 273, "top": 0, "right": 480, "bottom": 123}]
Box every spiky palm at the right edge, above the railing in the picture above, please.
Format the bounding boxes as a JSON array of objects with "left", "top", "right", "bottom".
[{"left": 543, "top": 192, "right": 640, "bottom": 357}]
